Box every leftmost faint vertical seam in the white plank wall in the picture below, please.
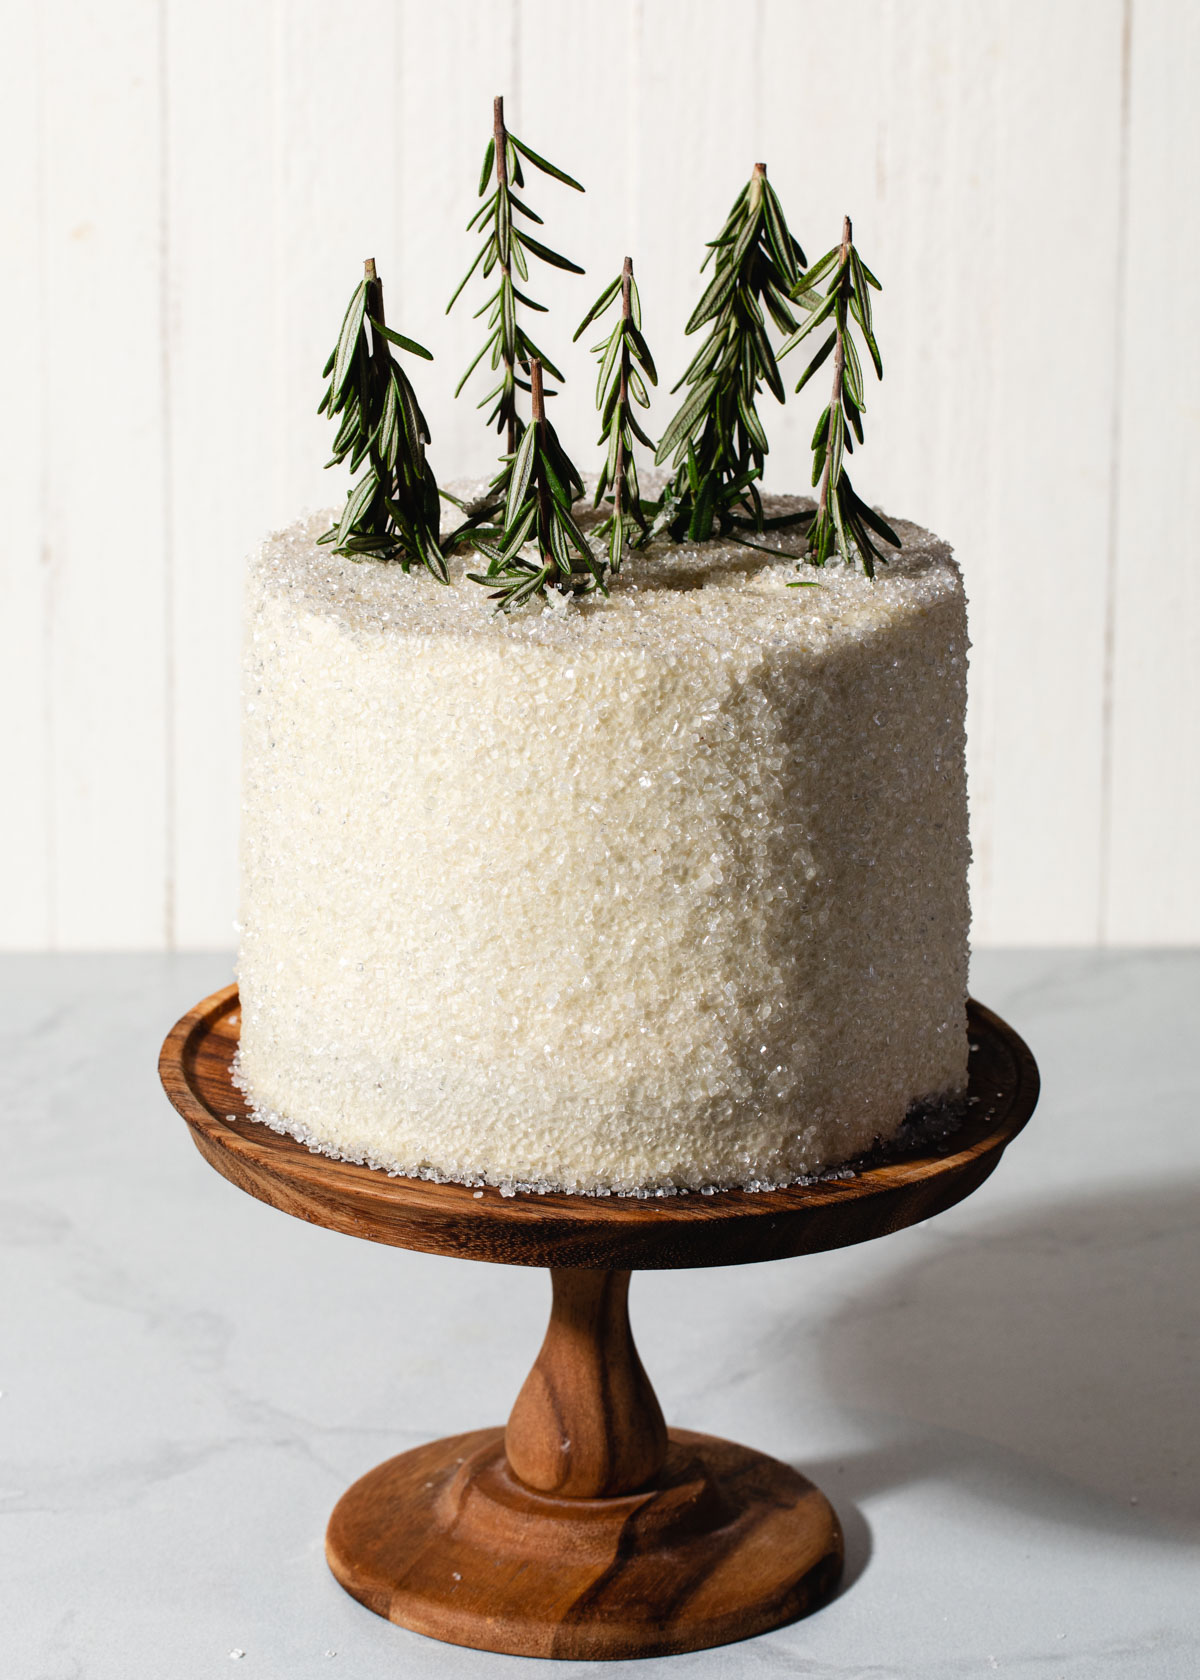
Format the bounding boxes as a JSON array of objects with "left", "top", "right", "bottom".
[{"left": 34, "top": 7, "right": 59, "bottom": 951}]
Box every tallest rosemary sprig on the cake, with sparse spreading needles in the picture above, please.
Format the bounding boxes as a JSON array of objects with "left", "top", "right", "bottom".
[{"left": 445, "top": 97, "right": 583, "bottom": 511}]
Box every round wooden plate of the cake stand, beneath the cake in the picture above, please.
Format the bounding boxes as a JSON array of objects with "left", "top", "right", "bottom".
[{"left": 158, "top": 986, "right": 1039, "bottom": 1270}]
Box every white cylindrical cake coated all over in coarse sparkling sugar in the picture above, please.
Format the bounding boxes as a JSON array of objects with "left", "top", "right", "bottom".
[{"left": 239, "top": 502, "right": 968, "bottom": 1193}]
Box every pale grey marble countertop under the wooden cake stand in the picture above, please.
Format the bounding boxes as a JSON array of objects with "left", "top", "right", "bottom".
[{"left": 0, "top": 951, "right": 1200, "bottom": 1680}]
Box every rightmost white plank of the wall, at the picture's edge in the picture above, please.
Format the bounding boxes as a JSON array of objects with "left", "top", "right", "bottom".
[{"left": 1103, "top": 5, "right": 1200, "bottom": 944}]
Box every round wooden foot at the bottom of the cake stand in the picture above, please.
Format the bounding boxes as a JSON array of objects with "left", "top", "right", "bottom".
[{"left": 326, "top": 1430, "right": 842, "bottom": 1660}]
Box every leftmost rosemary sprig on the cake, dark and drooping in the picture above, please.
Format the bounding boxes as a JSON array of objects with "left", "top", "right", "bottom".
[{"left": 318, "top": 257, "right": 449, "bottom": 583}]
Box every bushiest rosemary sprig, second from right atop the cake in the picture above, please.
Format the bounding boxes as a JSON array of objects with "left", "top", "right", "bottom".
[{"left": 650, "top": 163, "right": 805, "bottom": 543}]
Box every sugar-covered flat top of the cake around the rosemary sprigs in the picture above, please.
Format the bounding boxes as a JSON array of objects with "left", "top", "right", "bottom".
[{"left": 252, "top": 484, "right": 960, "bottom": 654}]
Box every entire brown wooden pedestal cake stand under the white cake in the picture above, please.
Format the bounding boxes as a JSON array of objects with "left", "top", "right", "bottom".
[{"left": 160, "top": 986, "right": 1039, "bottom": 1658}]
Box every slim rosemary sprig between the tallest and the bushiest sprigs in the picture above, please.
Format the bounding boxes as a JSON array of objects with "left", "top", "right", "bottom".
[{"left": 575, "top": 257, "right": 659, "bottom": 573}]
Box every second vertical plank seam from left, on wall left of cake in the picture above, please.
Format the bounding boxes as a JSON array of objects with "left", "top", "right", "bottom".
[{"left": 158, "top": 0, "right": 178, "bottom": 951}]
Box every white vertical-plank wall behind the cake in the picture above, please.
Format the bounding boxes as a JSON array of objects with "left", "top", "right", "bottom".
[{"left": 0, "top": 0, "right": 1200, "bottom": 949}]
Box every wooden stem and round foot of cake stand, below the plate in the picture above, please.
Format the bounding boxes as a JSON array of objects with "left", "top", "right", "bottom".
[{"left": 326, "top": 1270, "right": 842, "bottom": 1658}]
